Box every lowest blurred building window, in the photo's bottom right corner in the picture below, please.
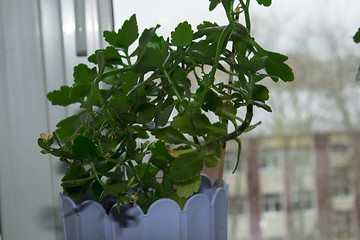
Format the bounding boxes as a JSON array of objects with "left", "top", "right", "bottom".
[{"left": 334, "top": 211, "right": 354, "bottom": 239}]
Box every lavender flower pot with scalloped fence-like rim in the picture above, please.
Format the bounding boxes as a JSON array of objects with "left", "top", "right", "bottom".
[{"left": 60, "top": 175, "right": 228, "bottom": 240}]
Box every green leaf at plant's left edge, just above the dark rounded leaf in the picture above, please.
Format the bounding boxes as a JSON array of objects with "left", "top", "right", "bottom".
[{"left": 56, "top": 113, "right": 83, "bottom": 140}]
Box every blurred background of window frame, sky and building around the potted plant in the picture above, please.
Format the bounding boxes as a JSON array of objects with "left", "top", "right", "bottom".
[{"left": 0, "top": 0, "right": 360, "bottom": 240}]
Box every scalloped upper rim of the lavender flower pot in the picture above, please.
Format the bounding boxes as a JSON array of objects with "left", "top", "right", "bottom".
[{"left": 59, "top": 174, "right": 229, "bottom": 216}]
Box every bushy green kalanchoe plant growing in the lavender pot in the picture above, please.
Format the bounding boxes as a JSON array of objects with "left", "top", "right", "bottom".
[{"left": 38, "top": 0, "right": 294, "bottom": 211}]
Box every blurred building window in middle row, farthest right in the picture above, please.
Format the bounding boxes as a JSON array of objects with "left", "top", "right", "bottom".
[{"left": 331, "top": 167, "right": 352, "bottom": 196}]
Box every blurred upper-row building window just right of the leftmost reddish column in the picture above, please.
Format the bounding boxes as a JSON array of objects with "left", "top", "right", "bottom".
[{"left": 260, "top": 148, "right": 284, "bottom": 170}]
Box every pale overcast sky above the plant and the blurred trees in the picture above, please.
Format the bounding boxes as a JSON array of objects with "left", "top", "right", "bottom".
[{"left": 113, "top": 0, "right": 360, "bottom": 55}]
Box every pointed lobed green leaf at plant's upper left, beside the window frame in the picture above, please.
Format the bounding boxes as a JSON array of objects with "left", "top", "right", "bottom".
[{"left": 104, "top": 14, "right": 139, "bottom": 50}]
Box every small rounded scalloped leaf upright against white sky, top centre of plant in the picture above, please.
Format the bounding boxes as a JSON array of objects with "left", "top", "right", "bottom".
[{"left": 171, "top": 21, "right": 194, "bottom": 47}]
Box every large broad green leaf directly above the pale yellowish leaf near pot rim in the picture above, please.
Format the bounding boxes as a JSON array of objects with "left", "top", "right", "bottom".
[{"left": 170, "top": 151, "right": 206, "bottom": 183}]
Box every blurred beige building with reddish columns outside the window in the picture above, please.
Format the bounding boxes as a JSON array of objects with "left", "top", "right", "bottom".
[{"left": 225, "top": 133, "right": 359, "bottom": 240}]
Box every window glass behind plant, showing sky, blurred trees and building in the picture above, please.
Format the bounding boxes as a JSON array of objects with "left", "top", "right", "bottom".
[{"left": 109, "top": 0, "right": 360, "bottom": 240}]
